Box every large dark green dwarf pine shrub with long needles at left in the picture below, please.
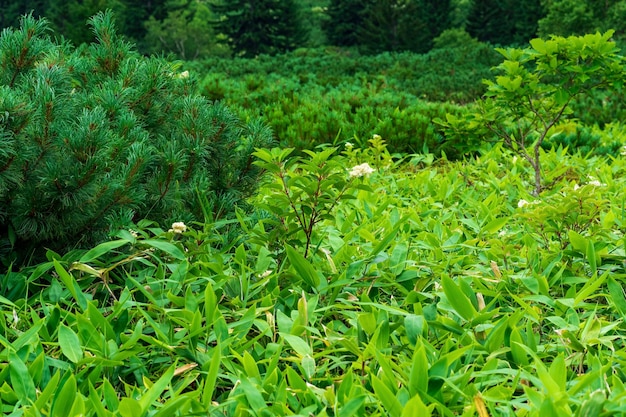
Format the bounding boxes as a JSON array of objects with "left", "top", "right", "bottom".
[{"left": 0, "top": 12, "right": 272, "bottom": 264}]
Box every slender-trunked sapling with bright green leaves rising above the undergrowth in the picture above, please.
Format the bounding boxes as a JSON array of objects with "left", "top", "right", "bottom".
[{"left": 440, "top": 31, "right": 625, "bottom": 195}]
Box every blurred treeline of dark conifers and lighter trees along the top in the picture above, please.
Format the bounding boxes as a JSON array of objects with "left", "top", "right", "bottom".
[{"left": 0, "top": 0, "right": 626, "bottom": 60}]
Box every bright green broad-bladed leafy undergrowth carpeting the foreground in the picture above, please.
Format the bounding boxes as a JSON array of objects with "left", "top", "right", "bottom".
[{"left": 0, "top": 141, "right": 626, "bottom": 417}]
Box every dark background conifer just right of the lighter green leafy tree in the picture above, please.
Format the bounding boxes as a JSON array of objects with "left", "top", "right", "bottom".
[{"left": 212, "top": 0, "right": 307, "bottom": 57}]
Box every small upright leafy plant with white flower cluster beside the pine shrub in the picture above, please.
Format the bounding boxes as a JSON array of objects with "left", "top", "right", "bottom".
[{"left": 254, "top": 148, "right": 375, "bottom": 257}]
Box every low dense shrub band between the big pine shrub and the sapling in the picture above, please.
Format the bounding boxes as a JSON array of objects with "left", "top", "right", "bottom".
[{"left": 186, "top": 37, "right": 499, "bottom": 156}]
